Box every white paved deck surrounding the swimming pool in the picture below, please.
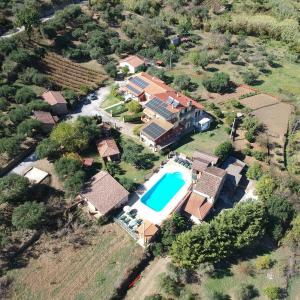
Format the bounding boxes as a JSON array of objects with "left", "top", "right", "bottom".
[{"left": 131, "top": 160, "right": 192, "bottom": 225}]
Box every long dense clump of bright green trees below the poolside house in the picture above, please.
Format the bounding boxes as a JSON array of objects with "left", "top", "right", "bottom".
[{"left": 169, "top": 201, "right": 265, "bottom": 269}]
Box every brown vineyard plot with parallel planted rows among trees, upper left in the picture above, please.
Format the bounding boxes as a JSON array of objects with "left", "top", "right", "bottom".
[{"left": 43, "top": 52, "right": 107, "bottom": 93}]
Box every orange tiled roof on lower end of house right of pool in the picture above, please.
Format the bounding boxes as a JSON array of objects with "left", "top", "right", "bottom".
[{"left": 183, "top": 192, "right": 212, "bottom": 221}]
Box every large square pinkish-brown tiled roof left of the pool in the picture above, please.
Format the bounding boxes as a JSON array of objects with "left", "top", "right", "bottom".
[{"left": 80, "top": 171, "right": 129, "bottom": 215}]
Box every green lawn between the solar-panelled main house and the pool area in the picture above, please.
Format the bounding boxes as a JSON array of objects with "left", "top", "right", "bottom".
[{"left": 176, "top": 125, "right": 229, "bottom": 157}]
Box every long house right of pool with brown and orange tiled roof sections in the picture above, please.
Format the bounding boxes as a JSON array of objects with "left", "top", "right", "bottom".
[{"left": 182, "top": 166, "right": 226, "bottom": 223}]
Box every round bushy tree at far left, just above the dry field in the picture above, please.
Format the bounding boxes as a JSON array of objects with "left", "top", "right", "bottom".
[{"left": 11, "top": 201, "right": 46, "bottom": 230}]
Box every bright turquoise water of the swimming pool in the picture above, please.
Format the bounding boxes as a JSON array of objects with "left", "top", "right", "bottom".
[{"left": 141, "top": 172, "right": 185, "bottom": 212}]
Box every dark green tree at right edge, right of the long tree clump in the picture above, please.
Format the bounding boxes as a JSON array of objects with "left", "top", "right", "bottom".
[{"left": 265, "top": 196, "right": 295, "bottom": 241}]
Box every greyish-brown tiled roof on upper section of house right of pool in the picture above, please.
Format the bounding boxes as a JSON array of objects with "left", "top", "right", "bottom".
[{"left": 194, "top": 167, "right": 226, "bottom": 198}]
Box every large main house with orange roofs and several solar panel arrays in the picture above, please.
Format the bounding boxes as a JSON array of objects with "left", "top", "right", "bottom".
[{"left": 123, "top": 72, "right": 211, "bottom": 151}]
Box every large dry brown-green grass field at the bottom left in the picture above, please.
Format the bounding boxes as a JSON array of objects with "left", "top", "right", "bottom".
[{"left": 9, "top": 224, "right": 143, "bottom": 300}]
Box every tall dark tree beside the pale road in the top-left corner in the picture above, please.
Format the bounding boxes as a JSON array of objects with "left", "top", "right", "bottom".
[{"left": 15, "top": 0, "right": 40, "bottom": 39}]
